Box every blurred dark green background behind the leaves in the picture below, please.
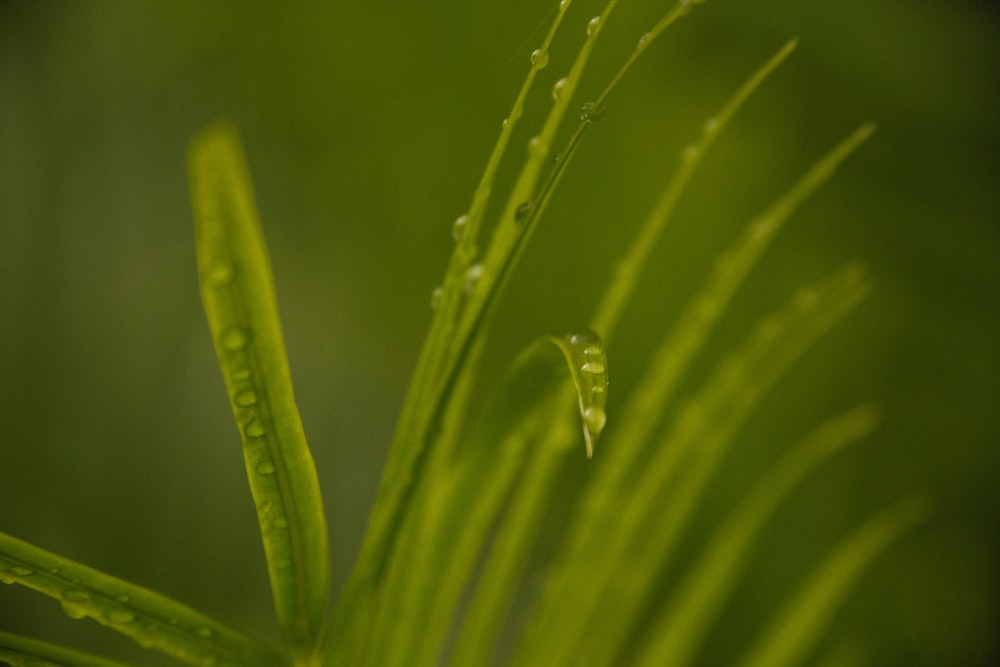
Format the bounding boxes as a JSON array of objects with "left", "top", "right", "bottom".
[{"left": 0, "top": 0, "right": 1000, "bottom": 665}]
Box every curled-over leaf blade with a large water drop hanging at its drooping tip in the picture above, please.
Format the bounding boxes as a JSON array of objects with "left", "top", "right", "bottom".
[{"left": 368, "top": 330, "right": 608, "bottom": 665}]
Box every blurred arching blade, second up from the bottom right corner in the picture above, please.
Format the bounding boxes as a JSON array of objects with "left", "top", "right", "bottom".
[{"left": 628, "top": 406, "right": 876, "bottom": 667}]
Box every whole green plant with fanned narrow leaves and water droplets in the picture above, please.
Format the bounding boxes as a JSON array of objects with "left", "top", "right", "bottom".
[{"left": 0, "top": 0, "right": 922, "bottom": 666}]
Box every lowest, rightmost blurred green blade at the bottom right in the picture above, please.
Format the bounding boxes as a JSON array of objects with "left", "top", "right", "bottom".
[{"left": 740, "top": 496, "right": 928, "bottom": 667}]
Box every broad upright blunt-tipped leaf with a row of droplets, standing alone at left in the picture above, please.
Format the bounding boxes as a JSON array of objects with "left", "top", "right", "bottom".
[{"left": 189, "top": 124, "right": 328, "bottom": 652}]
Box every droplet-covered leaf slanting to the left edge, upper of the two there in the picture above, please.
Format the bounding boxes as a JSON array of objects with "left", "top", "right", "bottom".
[{"left": 0, "top": 533, "right": 285, "bottom": 667}]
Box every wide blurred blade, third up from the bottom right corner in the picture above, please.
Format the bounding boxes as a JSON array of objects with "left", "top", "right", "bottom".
[{"left": 517, "top": 266, "right": 866, "bottom": 665}]
